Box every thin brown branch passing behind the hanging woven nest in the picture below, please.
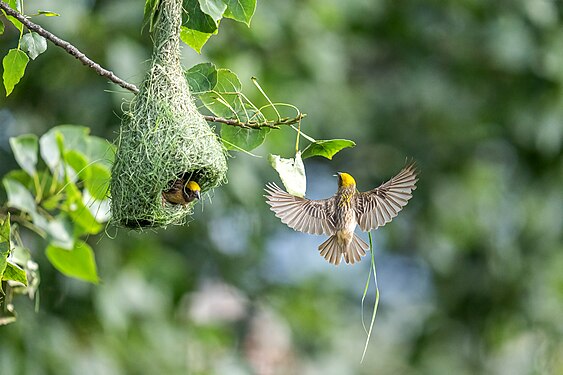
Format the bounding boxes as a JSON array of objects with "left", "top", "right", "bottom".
[{"left": 0, "top": 0, "right": 305, "bottom": 129}]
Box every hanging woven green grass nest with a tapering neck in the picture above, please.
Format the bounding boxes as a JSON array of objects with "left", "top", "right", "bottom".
[{"left": 110, "top": 0, "right": 227, "bottom": 229}]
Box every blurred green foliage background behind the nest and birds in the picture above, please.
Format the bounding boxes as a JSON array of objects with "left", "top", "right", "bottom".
[{"left": 0, "top": 0, "right": 563, "bottom": 375}]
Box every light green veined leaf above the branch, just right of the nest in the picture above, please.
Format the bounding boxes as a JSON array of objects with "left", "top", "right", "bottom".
[{"left": 199, "top": 69, "right": 242, "bottom": 118}]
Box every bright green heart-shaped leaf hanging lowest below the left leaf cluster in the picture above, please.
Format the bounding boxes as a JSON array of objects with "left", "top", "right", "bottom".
[{"left": 46, "top": 241, "right": 99, "bottom": 284}]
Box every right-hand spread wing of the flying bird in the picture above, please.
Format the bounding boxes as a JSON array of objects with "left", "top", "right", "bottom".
[{"left": 355, "top": 163, "right": 418, "bottom": 232}]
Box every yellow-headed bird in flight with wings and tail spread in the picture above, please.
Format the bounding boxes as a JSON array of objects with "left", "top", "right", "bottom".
[{"left": 265, "top": 163, "right": 418, "bottom": 266}]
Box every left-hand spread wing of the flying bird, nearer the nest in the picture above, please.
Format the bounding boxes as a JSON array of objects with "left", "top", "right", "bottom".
[{"left": 264, "top": 183, "right": 335, "bottom": 235}]
